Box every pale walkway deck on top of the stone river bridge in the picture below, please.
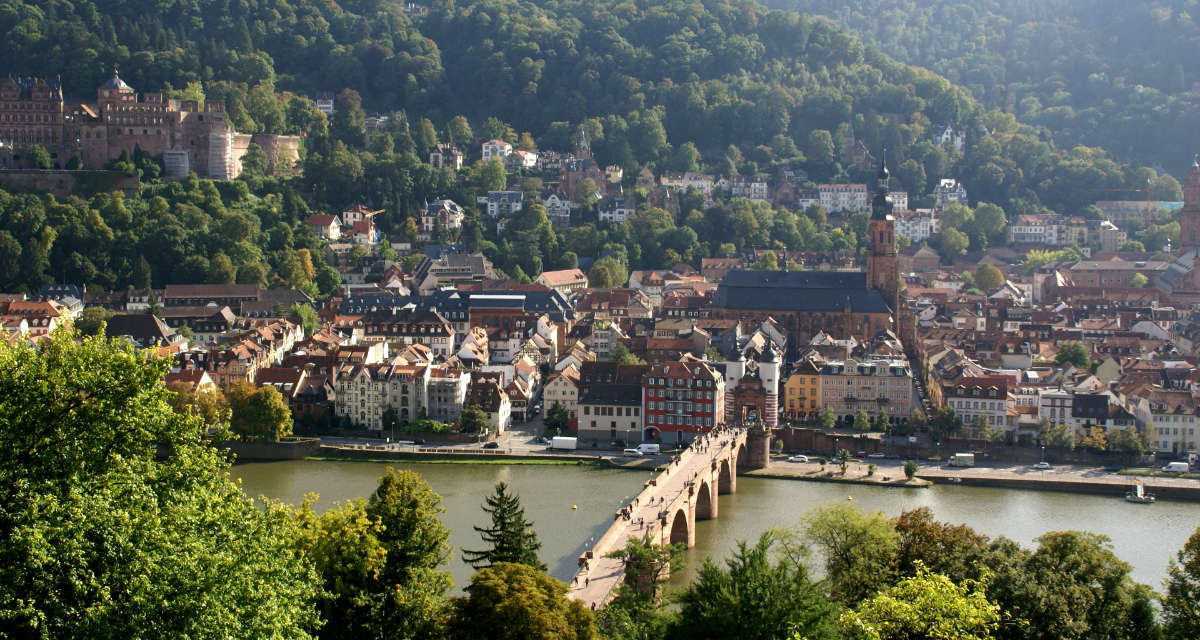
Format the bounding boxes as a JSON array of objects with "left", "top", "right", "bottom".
[{"left": 569, "top": 429, "right": 745, "bottom": 609}]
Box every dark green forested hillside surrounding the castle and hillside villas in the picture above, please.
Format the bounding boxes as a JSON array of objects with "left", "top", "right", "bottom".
[{"left": 0, "top": 0, "right": 1180, "bottom": 292}]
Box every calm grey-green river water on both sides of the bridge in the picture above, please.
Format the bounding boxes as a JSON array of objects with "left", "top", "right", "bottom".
[{"left": 232, "top": 461, "right": 1200, "bottom": 588}]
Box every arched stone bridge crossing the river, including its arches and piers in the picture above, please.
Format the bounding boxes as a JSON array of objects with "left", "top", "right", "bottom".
[{"left": 569, "top": 429, "right": 766, "bottom": 610}]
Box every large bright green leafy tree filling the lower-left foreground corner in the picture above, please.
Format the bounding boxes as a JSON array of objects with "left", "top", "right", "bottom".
[{"left": 0, "top": 330, "right": 318, "bottom": 640}]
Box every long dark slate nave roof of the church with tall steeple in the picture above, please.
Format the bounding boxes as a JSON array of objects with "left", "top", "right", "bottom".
[{"left": 713, "top": 269, "right": 890, "bottom": 313}]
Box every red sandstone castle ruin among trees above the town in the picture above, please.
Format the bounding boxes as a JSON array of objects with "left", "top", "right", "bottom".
[{"left": 0, "top": 68, "right": 299, "bottom": 180}]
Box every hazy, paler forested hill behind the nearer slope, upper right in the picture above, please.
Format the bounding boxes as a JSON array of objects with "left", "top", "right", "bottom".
[{"left": 767, "top": 0, "right": 1200, "bottom": 173}]
